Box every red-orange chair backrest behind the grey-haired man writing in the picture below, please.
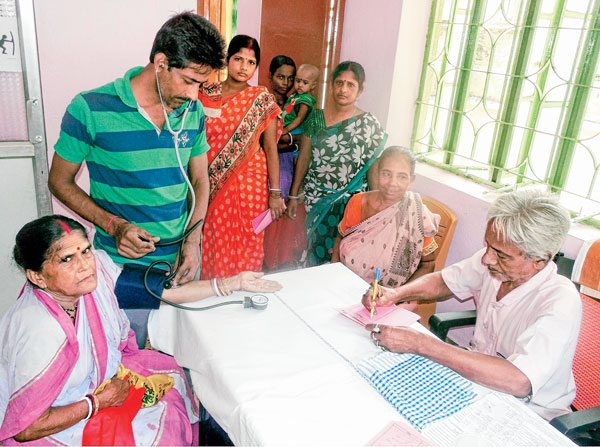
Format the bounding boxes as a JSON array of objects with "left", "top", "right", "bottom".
[{"left": 572, "top": 293, "right": 600, "bottom": 410}]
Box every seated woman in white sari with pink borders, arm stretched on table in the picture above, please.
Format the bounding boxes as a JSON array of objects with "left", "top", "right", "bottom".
[{"left": 0, "top": 216, "right": 280, "bottom": 445}]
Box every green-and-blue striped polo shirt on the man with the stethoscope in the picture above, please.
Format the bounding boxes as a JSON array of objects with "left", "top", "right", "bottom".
[{"left": 54, "top": 67, "right": 209, "bottom": 264}]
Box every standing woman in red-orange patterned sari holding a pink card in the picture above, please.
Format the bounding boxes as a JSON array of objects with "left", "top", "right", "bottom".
[{"left": 199, "top": 35, "right": 284, "bottom": 278}]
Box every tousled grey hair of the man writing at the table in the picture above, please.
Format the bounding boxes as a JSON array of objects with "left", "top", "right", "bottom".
[{"left": 488, "top": 190, "right": 570, "bottom": 261}]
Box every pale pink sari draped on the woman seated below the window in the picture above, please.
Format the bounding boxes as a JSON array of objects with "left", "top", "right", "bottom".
[{"left": 340, "top": 191, "right": 440, "bottom": 287}]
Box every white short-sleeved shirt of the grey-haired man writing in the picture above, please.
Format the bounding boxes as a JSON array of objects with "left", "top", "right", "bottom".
[{"left": 442, "top": 249, "right": 581, "bottom": 420}]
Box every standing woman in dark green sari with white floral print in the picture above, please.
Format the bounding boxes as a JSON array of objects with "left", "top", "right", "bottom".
[{"left": 287, "top": 61, "right": 387, "bottom": 266}]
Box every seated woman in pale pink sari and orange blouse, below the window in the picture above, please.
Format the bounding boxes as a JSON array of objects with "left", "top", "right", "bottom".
[{"left": 332, "top": 146, "right": 440, "bottom": 308}]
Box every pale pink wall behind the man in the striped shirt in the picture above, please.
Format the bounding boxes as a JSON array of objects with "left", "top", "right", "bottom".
[{"left": 35, "top": 0, "right": 196, "bottom": 229}]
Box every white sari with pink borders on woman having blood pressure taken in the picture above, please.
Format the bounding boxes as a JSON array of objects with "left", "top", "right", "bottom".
[{"left": 0, "top": 251, "right": 198, "bottom": 445}]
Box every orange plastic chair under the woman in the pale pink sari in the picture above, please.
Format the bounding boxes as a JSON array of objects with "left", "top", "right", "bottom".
[{"left": 416, "top": 196, "right": 458, "bottom": 327}]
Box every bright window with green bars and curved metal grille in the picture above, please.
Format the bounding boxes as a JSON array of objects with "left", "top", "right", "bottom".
[{"left": 412, "top": 0, "right": 600, "bottom": 224}]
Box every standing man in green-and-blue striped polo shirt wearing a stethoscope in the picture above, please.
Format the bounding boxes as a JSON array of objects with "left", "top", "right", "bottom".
[{"left": 48, "top": 12, "right": 225, "bottom": 284}]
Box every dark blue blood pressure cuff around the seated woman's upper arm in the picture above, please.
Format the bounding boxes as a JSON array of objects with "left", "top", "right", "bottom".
[{"left": 115, "top": 264, "right": 167, "bottom": 309}]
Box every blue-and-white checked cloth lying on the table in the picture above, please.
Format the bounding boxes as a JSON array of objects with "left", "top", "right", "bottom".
[{"left": 358, "top": 352, "right": 477, "bottom": 430}]
